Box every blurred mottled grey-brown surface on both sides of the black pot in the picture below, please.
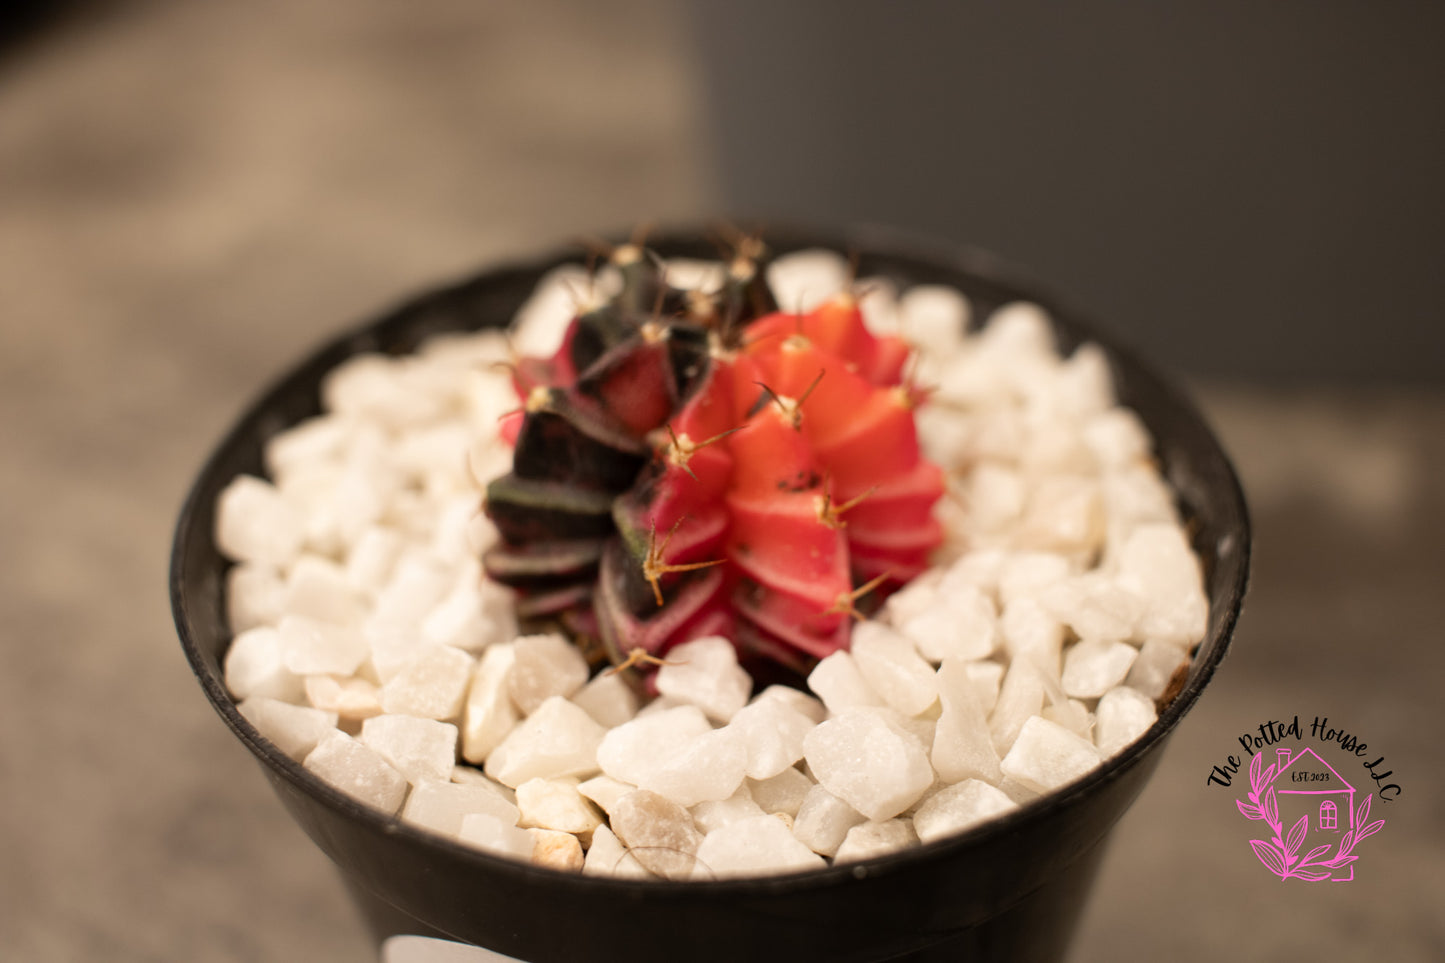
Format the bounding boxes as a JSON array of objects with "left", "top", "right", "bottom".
[{"left": 0, "top": 0, "right": 1445, "bottom": 963}]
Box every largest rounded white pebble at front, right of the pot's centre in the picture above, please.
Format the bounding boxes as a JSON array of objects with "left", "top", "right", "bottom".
[{"left": 803, "top": 709, "right": 933, "bottom": 820}]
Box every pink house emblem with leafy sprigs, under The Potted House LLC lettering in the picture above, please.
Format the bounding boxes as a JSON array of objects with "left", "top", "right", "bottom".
[{"left": 1234, "top": 749, "right": 1384, "bottom": 882}]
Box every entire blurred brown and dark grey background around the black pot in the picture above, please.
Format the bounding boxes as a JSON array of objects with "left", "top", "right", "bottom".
[{"left": 0, "top": 0, "right": 1445, "bottom": 963}]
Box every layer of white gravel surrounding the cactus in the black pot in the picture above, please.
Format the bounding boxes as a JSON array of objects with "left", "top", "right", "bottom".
[{"left": 215, "top": 252, "right": 1208, "bottom": 879}]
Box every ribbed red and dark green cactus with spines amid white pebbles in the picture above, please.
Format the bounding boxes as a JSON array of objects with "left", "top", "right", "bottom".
[{"left": 483, "top": 240, "right": 944, "bottom": 678}]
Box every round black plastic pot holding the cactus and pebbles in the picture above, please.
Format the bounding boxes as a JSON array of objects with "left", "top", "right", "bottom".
[{"left": 171, "top": 228, "right": 1250, "bottom": 963}]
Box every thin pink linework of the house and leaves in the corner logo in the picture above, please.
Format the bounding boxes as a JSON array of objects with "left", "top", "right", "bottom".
[{"left": 1234, "top": 749, "right": 1384, "bottom": 882}]
